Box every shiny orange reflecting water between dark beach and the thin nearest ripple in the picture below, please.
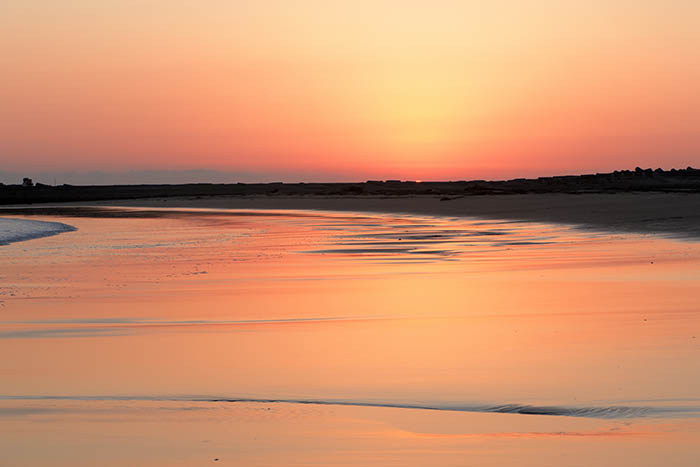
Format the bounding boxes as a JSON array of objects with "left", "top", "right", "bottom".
[{"left": 0, "top": 210, "right": 700, "bottom": 465}]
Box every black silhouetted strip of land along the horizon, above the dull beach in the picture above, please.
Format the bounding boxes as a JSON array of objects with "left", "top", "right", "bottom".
[{"left": 0, "top": 167, "right": 700, "bottom": 204}]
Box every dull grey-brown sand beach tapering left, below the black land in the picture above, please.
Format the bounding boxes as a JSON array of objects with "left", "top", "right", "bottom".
[{"left": 54, "top": 193, "right": 700, "bottom": 240}]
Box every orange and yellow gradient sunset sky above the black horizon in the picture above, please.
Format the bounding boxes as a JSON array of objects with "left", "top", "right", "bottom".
[{"left": 0, "top": 0, "right": 700, "bottom": 181}]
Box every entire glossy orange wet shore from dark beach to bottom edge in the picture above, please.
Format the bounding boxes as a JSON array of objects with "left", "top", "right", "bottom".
[{"left": 0, "top": 210, "right": 700, "bottom": 465}]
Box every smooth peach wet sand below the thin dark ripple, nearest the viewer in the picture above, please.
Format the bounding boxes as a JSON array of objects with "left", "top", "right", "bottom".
[{"left": 0, "top": 401, "right": 700, "bottom": 467}]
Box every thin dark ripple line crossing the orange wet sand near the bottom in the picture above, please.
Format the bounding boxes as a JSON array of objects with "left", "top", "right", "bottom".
[{"left": 0, "top": 395, "right": 700, "bottom": 419}]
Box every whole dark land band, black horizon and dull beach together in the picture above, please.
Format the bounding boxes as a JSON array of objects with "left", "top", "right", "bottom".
[{"left": 0, "top": 168, "right": 700, "bottom": 240}]
